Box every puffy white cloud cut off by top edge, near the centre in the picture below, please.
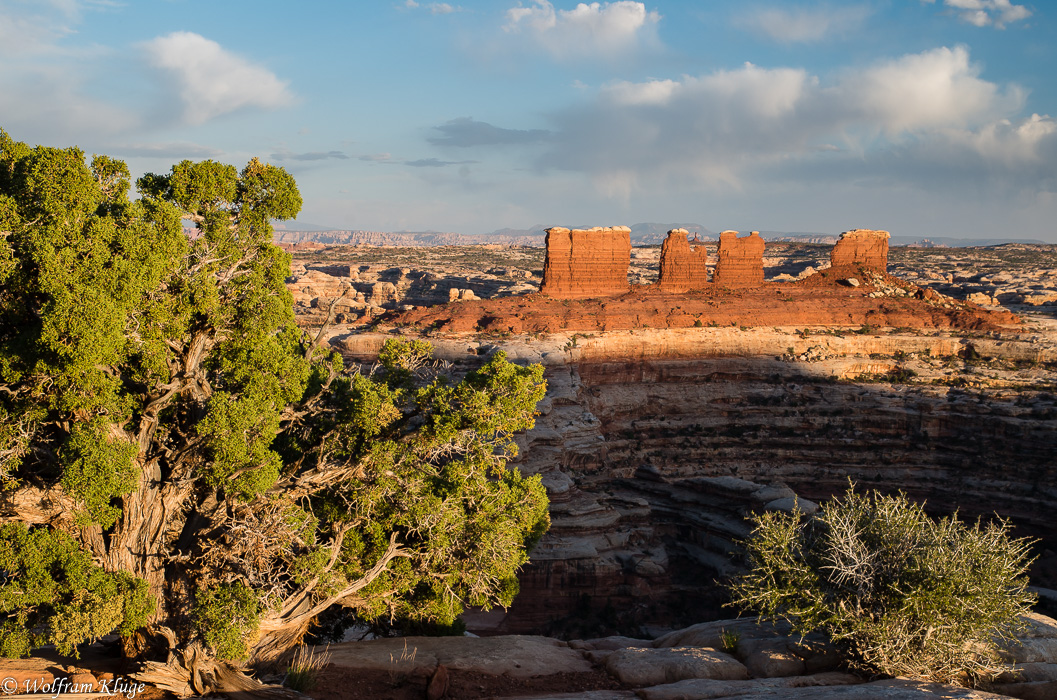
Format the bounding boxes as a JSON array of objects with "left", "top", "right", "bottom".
[{"left": 503, "top": 0, "right": 661, "bottom": 58}]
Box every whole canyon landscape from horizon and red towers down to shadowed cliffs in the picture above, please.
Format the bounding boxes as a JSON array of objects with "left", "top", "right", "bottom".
[{"left": 291, "top": 228, "right": 1057, "bottom": 672}]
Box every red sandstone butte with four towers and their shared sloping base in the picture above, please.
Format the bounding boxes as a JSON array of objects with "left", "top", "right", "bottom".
[{"left": 388, "top": 226, "right": 1020, "bottom": 333}]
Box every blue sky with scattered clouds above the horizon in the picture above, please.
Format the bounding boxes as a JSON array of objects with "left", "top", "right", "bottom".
[{"left": 0, "top": 0, "right": 1057, "bottom": 242}]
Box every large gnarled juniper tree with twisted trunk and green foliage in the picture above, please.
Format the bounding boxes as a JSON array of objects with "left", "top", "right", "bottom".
[{"left": 0, "top": 131, "right": 549, "bottom": 692}]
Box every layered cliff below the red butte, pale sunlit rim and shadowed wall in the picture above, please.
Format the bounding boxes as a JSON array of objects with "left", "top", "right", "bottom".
[{"left": 336, "top": 328, "right": 1057, "bottom": 635}]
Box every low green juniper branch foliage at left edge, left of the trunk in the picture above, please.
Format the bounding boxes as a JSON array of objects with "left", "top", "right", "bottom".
[{"left": 0, "top": 523, "right": 154, "bottom": 658}]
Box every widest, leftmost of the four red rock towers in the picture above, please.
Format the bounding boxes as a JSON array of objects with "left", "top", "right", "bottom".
[{"left": 540, "top": 226, "right": 631, "bottom": 299}]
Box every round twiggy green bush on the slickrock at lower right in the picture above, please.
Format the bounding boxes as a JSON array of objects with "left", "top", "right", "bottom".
[{"left": 731, "top": 489, "right": 1034, "bottom": 683}]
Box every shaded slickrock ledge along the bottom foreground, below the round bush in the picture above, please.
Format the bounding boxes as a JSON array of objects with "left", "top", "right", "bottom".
[{"left": 295, "top": 614, "right": 1057, "bottom": 700}]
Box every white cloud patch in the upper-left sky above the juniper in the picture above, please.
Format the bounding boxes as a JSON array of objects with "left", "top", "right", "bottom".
[{"left": 141, "top": 32, "right": 294, "bottom": 125}]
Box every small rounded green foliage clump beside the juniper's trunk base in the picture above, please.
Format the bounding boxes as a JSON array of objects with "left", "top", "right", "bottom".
[{"left": 194, "top": 582, "right": 261, "bottom": 661}]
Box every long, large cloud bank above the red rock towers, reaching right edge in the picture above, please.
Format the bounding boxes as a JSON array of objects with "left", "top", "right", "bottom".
[{"left": 538, "top": 48, "right": 1057, "bottom": 196}]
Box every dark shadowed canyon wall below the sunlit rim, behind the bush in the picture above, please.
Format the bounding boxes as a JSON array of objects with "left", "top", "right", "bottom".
[{"left": 495, "top": 357, "right": 1057, "bottom": 635}]
